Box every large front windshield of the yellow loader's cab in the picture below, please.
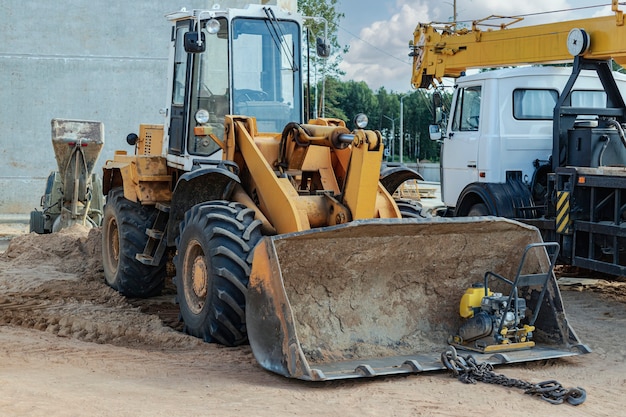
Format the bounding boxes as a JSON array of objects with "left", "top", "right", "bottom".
[{"left": 232, "top": 18, "right": 302, "bottom": 132}]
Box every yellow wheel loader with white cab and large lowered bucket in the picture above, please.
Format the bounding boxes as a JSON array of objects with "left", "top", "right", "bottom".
[{"left": 102, "top": 2, "right": 588, "bottom": 380}]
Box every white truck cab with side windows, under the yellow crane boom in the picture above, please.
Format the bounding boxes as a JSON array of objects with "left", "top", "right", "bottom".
[{"left": 441, "top": 67, "right": 626, "bottom": 218}]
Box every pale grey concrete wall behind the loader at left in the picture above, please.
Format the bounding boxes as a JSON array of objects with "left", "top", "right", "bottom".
[{"left": 0, "top": 0, "right": 214, "bottom": 219}]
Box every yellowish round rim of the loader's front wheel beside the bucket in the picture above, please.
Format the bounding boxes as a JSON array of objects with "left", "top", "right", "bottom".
[{"left": 183, "top": 240, "right": 209, "bottom": 314}]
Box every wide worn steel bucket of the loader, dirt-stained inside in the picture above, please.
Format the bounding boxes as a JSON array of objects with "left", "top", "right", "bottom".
[{"left": 246, "top": 217, "right": 589, "bottom": 381}]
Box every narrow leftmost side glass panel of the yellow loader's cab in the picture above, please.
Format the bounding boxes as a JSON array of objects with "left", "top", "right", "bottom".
[{"left": 169, "top": 21, "right": 192, "bottom": 155}]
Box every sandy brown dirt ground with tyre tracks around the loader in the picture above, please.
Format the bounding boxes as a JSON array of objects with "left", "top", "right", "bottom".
[{"left": 0, "top": 225, "right": 626, "bottom": 417}]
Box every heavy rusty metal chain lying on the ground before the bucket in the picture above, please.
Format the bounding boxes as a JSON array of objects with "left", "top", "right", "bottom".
[{"left": 441, "top": 346, "right": 587, "bottom": 405}]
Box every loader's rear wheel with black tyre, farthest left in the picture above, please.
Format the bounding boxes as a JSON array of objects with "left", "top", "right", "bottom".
[{"left": 102, "top": 188, "right": 166, "bottom": 298}]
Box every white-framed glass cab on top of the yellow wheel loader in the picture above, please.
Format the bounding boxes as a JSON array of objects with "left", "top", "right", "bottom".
[{"left": 164, "top": 5, "right": 303, "bottom": 171}]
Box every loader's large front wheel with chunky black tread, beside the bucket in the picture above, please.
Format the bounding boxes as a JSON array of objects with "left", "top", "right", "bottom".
[{"left": 174, "top": 201, "right": 261, "bottom": 346}]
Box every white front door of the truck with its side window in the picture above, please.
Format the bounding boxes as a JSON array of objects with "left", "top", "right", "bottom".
[{"left": 441, "top": 85, "right": 481, "bottom": 207}]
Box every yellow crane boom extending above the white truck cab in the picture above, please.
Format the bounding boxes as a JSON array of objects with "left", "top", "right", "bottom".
[{"left": 410, "top": 0, "right": 626, "bottom": 88}]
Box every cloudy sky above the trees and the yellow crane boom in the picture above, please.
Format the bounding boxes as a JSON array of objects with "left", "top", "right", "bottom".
[{"left": 337, "top": 0, "right": 626, "bottom": 93}]
